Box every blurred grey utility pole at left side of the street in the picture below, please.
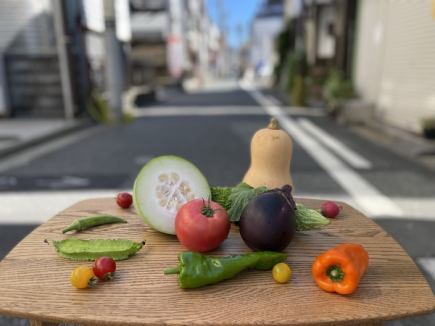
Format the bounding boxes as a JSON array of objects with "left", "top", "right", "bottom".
[{"left": 103, "top": 0, "right": 123, "bottom": 121}]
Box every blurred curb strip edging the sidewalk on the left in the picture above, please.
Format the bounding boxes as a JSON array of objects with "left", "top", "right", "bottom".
[{"left": 0, "top": 120, "right": 95, "bottom": 159}]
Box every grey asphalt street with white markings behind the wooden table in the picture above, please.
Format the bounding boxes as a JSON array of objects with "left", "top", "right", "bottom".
[{"left": 0, "top": 85, "right": 435, "bottom": 325}]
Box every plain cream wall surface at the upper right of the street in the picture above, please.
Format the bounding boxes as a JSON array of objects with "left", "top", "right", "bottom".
[{"left": 354, "top": 0, "right": 435, "bottom": 132}]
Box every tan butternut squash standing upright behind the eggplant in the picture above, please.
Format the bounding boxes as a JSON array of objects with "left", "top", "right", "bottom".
[{"left": 243, "top": 118, "right": 294, "bottom": 189}]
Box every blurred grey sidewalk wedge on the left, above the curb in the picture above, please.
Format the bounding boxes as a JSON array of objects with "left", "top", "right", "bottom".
[{"left": 0, "top": 118, "right": 91, "bottom": 158}]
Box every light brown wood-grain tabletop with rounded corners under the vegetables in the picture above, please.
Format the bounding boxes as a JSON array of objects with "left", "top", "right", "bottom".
[{"left": 0, "top": 198, "right": 435, "bottom": 325}]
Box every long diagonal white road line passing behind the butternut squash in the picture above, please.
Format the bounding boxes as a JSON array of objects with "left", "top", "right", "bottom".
[{"left": 249, "top": 90, "right": 403, "bottom": 217}]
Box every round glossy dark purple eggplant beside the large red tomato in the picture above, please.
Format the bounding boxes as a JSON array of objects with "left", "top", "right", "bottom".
[{"left": 239, "top": 185, "right": 296, "bottom": 251}]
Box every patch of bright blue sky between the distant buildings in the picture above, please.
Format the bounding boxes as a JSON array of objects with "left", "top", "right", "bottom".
[{"left": 206, "top": 0, "right": 263, "bottom": 47}]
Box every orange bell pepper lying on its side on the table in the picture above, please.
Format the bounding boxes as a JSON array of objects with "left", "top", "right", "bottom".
[{"left": 311, "top": 243, "right": 369, "bottom": 294}]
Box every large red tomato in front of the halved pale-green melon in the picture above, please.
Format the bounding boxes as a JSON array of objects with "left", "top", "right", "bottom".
[{"left": 175, "top": 199, "right": 231, "bottom": 252}]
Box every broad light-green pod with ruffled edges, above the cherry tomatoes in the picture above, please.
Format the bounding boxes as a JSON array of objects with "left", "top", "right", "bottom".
[{"left": 53, "top": 238, "right": 145, "bottom": 261}]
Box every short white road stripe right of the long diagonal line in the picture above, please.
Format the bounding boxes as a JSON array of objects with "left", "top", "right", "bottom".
[{"left": 298, "top": 118, "right": 372, "bottom": 169}]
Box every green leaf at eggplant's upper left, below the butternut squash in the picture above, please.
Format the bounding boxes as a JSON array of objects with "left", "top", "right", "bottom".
[{"left": 228, "top": 182, "right": 268, "bottom": 222}]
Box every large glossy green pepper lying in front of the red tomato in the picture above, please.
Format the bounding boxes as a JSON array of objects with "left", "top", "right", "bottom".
[{"left": 164, "top": 251, "right": 287, "bottom": 289}]
